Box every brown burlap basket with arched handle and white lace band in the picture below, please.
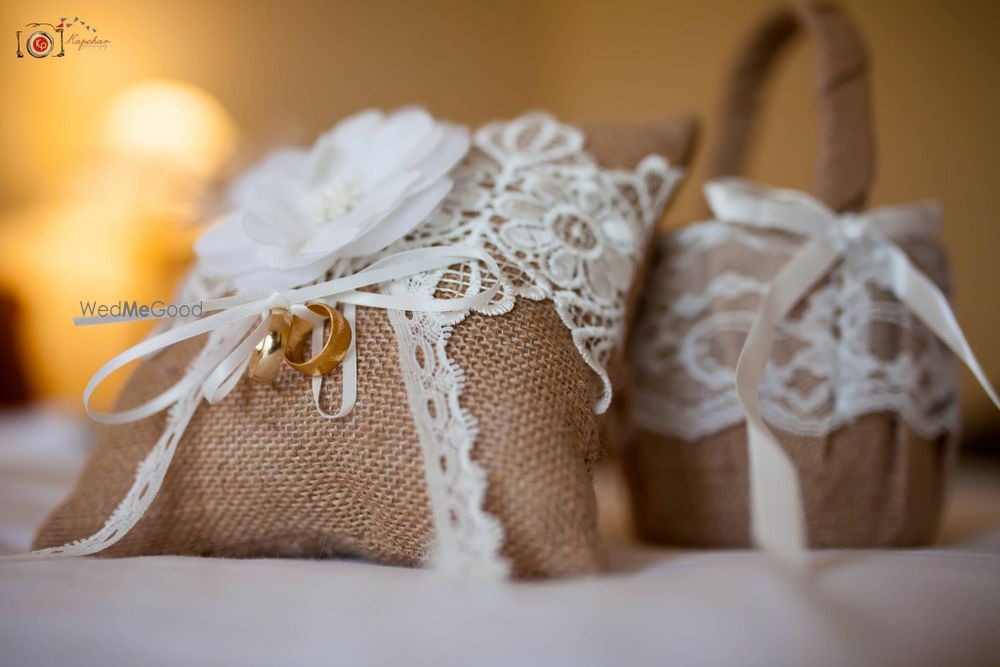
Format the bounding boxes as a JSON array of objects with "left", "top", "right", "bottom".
[{"left": 625, "top": 5, "right": 958, "bottom": 547}]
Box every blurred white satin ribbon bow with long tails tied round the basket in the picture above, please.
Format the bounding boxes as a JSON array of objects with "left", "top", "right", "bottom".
[{"left": 705, "top": 178, "right": 1000, "bottom": 569}]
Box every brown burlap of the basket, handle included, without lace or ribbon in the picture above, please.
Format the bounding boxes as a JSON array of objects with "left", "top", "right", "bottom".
[{"left": 624, "top": 6, "right": 956, "bottom": 547}]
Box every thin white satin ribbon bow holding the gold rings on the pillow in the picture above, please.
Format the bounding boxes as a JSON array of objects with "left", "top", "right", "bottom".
[{"left": 77, "top": 246, "right": 501, "bottom": 424}]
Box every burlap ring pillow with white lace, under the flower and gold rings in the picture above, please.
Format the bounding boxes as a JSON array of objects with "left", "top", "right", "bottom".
[{"left": 35, "top": 114, "right": 692, "bottom": 577}]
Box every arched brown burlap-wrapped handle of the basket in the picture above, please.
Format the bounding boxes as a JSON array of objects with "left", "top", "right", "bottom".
[{"left": 709, "top": 3, "right": 875, "bottom": 211}]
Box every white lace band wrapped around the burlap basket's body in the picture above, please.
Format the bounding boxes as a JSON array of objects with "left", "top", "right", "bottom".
[{"left": 631, "top": 221, "right": 959, "bottom": 441}]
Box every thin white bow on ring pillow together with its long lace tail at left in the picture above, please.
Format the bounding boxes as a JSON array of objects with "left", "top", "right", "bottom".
[{"left": 0, "top": 246, "right": 502, "bottom": 561}]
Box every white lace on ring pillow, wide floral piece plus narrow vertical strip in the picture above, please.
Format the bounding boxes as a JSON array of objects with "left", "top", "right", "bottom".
[{"left": 376, "top": 114, "right": 681, "bottom": 576}]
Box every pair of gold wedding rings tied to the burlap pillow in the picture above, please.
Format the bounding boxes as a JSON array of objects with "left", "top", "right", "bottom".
[{"left": 247, "top": 303, "right": 351, "bottom": 384}]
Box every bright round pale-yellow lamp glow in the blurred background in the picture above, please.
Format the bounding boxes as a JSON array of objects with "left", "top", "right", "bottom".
[{"left": 104, "top": 80, "right": 235, "bottom": 175}]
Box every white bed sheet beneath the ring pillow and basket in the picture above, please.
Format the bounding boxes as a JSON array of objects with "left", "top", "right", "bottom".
[{"left": 0, "top": 410, "right": 1000, "bottom": 667}]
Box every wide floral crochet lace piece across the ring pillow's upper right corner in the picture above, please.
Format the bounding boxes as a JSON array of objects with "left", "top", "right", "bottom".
[{"left": 386, "top": 113, "right": 682, "bottom": 404}]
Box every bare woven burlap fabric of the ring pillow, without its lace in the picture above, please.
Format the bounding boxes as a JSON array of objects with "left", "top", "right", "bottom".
[{"left": 35, "top": 118, "right": 693, "bottom": 577}]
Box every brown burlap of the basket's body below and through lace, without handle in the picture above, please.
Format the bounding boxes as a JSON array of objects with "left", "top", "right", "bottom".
[{"left": 623, "top": 235, "right": 956, "bottom": 547}]
